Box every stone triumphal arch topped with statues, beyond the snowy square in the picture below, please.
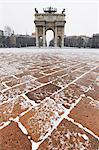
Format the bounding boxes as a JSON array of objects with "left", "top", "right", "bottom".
[{"left": 34, "top": 7, "right": 66, "bottom": 47}]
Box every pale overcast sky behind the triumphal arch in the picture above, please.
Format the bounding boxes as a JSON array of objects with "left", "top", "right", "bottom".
[{"left": 0, "top": 0, "right": 99, "bottom": 36}]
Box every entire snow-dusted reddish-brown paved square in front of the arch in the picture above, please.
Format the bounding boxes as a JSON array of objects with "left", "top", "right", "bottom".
[{"left": 0, "top": 49, "right": 99, "bottom": 150}]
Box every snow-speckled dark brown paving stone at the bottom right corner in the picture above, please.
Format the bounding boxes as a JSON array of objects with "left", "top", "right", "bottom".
[{"left": 38, "top": 119, "right": 99, "bottom": 150}]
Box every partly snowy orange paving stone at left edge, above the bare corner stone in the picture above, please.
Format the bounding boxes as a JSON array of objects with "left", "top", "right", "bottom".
[{"left": 0, "top": 96, "right": 31, "bottom": 125}]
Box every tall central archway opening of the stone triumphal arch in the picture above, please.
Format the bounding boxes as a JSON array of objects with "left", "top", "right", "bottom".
[{"left": 46, "top": 29, "right": 55, "bottom": 47}]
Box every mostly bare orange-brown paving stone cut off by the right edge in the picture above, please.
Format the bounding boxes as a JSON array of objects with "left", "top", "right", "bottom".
[{"left": 69, "top": 97, "right": 99, "bottom": 136}]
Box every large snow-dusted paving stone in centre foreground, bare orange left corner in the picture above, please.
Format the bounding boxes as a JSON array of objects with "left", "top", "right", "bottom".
[{"left": 20, "top": 98, "right": 64, "bottom": 142}]
